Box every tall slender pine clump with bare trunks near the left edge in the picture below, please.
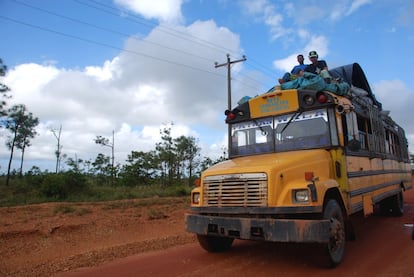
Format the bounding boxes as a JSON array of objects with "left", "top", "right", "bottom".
[{"left": 6, "top": 104, "right": 39, "bottom": 185}]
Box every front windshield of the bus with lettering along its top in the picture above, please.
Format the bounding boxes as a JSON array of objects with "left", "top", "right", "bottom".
[{"left": 230, "top": 109, "right": 331, "bottom": 156}]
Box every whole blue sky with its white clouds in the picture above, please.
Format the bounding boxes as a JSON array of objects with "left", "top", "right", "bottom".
[{"left": 0, "top": 0, "right": 414, "bottom": 173}]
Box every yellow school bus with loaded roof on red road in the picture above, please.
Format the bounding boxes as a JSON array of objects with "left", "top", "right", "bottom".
[{"left": 185, "top": 63, "right": 411, "bottom": 266}]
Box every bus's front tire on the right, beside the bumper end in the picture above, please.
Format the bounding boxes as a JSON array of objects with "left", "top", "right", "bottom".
[{"left": 323, "top": 199, "right": 346, "bottom": 267}]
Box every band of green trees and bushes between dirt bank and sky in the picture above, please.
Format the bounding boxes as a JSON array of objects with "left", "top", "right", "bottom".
[{"left": 0, "top": 124, "right": 224, "bottom": 206}]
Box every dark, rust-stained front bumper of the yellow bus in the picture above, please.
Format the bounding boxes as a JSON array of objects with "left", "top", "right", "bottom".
[{"left": 185, "top": 214, "right": 331, "bottom": 243}]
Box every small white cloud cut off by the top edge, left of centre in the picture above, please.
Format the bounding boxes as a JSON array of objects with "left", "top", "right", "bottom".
[{"left": 115, "top": 0, "right": 183, "bottom": 23}]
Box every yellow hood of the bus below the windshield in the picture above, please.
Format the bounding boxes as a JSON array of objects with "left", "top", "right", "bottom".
[{"left": 201, "top": 149, "right": 334, "bottom": 207}]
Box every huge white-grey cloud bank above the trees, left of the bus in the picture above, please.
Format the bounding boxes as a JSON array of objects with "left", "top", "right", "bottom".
[{"left": 0, "top": 21, "right": 247, "bottom": 171}]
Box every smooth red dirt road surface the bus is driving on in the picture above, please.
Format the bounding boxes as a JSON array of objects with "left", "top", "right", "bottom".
[{"left": 61, "top": 189, "right": 414, "bottom": 277}]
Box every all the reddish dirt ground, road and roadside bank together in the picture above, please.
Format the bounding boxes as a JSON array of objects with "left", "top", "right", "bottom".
[{"left": 0, "top": 184, "right": 414, "bottom": 277}]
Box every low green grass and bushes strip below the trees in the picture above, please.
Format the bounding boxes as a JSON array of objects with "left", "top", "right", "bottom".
[{"left": 0, "top": 172, "right": 195, "bottom": 206}]
